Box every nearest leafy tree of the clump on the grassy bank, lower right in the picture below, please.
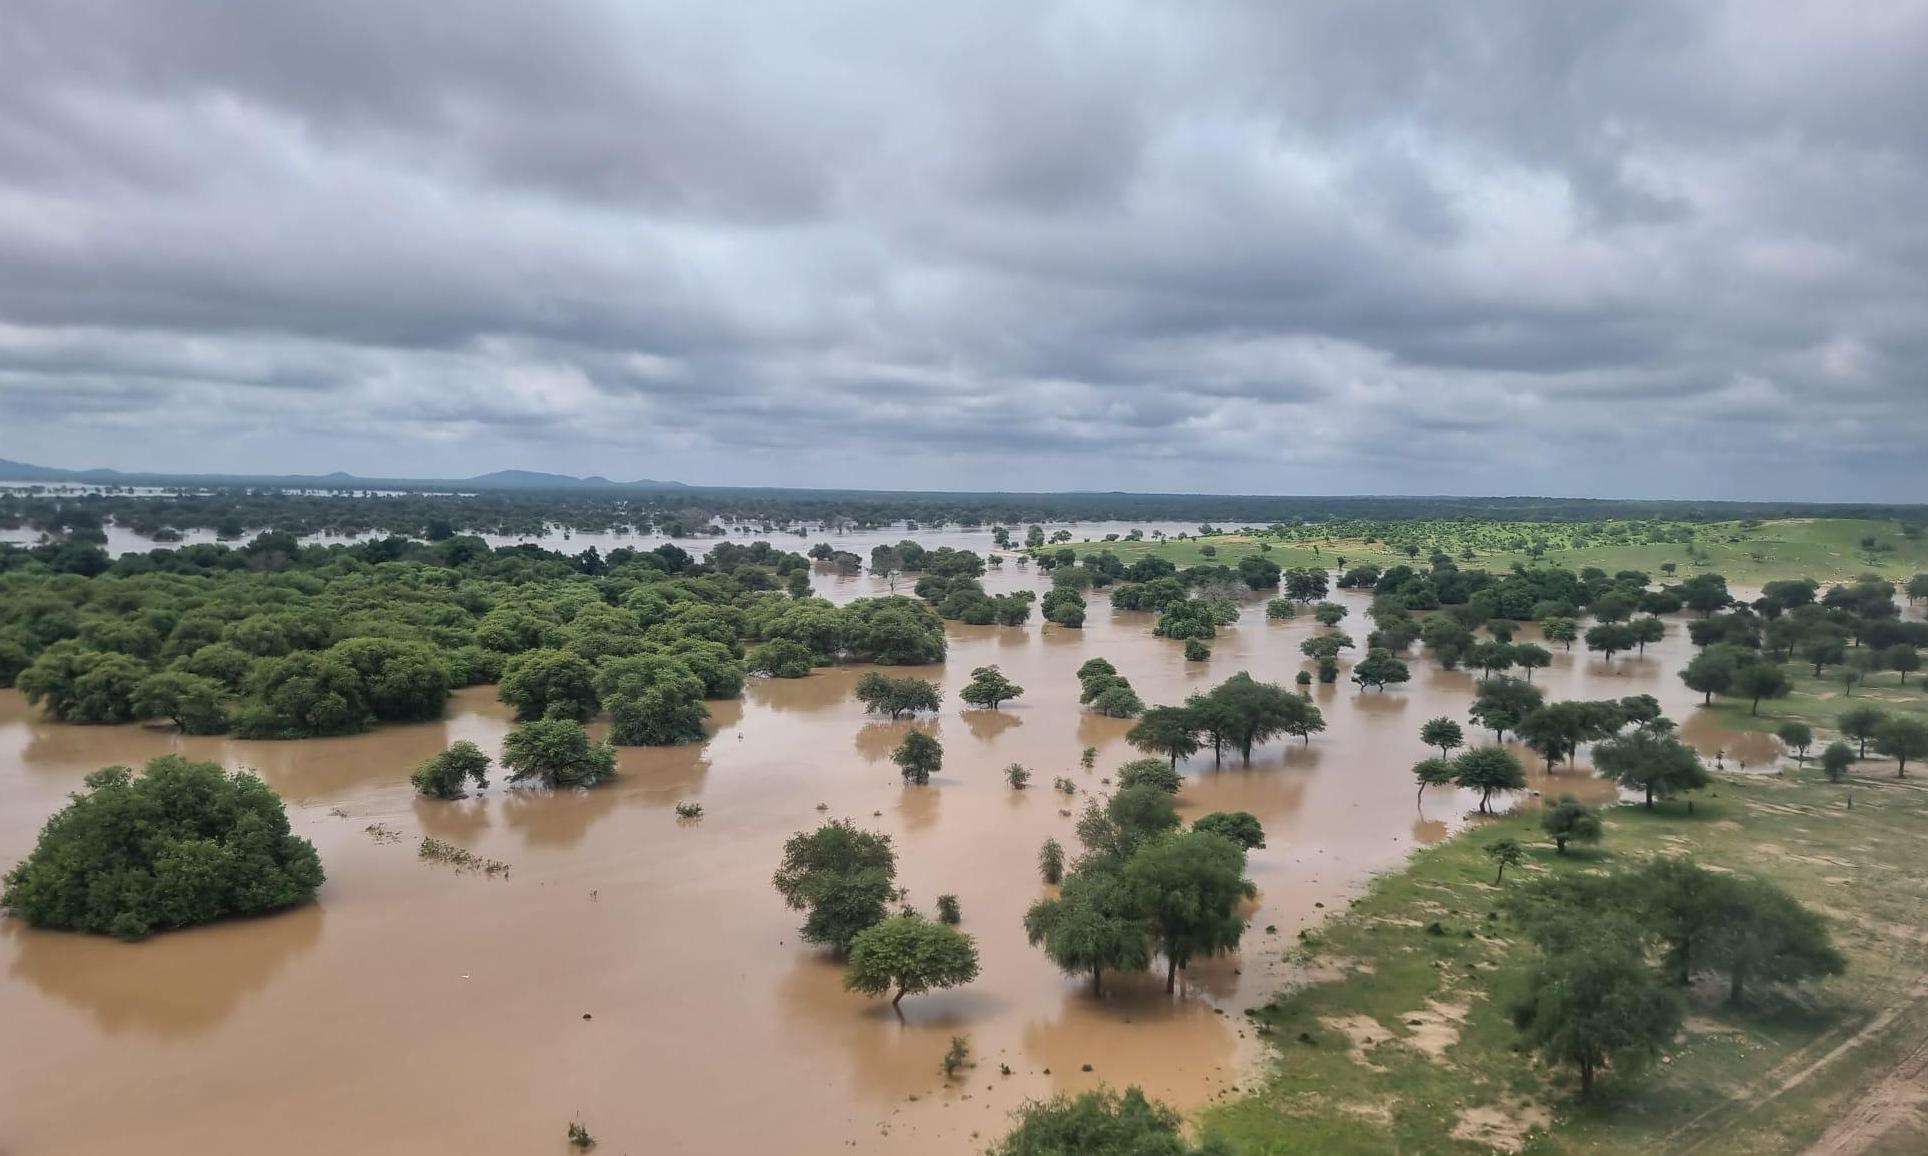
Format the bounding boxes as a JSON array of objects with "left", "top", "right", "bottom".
[{"left": 1513, "top": 923, "right": 1683, "bottom": 1096}]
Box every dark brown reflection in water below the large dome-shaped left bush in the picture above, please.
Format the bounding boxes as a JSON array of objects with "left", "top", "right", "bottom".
[{"left": 4, "top": 904, "right": 322, "bottom": 1038}]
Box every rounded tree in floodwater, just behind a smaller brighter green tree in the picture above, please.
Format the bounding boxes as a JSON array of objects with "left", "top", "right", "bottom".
[{"left": 771, "top": 819, "right": 897, "bottom": 952}]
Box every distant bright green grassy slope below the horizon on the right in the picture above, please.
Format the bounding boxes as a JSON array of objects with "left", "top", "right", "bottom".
[{"left": 1045, "top": 518, "right": 1928, "bottom": 586}]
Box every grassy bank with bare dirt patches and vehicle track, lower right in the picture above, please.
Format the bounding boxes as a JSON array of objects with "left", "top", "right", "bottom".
[{"left": 1201, "top": 766, "right": 1928, "bottom": 1156}]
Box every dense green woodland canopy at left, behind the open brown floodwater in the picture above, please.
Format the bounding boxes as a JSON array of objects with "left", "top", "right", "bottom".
[{"left": 0, "top": 534, "right": 945, "bottom": 744}]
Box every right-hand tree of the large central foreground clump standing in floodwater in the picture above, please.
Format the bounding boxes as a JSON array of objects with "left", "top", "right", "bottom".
[{"left": 1124, "top": 830, "right": 1257, "bottom": 992}]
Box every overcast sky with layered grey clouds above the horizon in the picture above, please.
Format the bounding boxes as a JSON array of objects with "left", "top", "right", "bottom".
[{"left": 0, "top": 0, "right": 1928, "bottom": 501}]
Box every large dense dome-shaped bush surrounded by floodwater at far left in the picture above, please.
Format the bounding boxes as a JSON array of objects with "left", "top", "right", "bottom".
[{"left": 0, "top": 755, "right": 322, "bottom": 938}]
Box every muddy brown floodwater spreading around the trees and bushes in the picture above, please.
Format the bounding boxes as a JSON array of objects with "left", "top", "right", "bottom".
[{"left": 0, "top": 568, "right": 1772, "bottom": 1156}]
